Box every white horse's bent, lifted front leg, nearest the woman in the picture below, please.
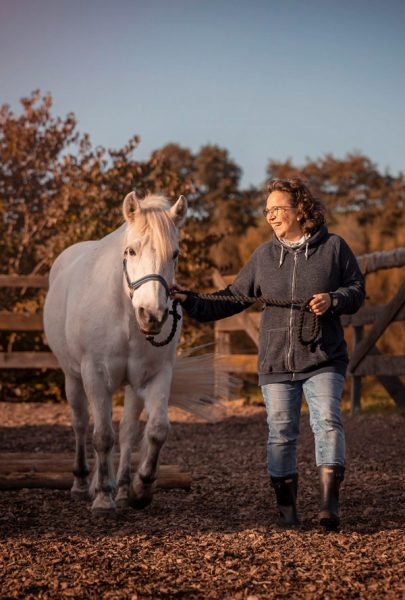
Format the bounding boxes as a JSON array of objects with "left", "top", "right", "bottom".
[{"left": 130, "top": 366, "right": 172, "bottom": 508}]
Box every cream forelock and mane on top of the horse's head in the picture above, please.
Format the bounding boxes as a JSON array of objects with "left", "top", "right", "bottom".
[{"left": 126, "top": 194, "right": 177, "bottom": 259}]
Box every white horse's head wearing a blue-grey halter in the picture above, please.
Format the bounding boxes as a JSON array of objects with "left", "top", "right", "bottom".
[{"left": 123, "top": 192, "right": 187, "bottom": 335}]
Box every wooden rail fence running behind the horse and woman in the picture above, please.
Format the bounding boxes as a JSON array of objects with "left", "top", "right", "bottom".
[{"left": 0, "top": 247, "right": 405, "bottom": 412}]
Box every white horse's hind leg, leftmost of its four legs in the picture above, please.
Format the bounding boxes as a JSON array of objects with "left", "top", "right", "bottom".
[{"left": 65, "top": 375, "right": 89, "bottom": 500}]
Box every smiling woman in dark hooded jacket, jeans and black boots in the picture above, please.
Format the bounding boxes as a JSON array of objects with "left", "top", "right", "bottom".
[{"left": 175, "top": 178, "right": 364, "bottom": 530}]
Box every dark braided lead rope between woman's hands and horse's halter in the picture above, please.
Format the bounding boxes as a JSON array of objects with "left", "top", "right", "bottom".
[{"left": 146, "top": 290, "right": 321, "bottom": 348}]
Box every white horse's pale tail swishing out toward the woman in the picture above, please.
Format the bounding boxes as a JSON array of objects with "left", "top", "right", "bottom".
[{"left": 169, "top": 352, "right": 238, "bottom": 421}]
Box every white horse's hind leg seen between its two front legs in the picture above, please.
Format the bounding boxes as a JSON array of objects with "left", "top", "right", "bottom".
[{"left": 115, "top": 385, "right": 143, "bottom": 508}]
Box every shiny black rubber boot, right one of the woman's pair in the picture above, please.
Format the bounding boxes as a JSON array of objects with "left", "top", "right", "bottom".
[{"left": 319, "top": 465, "right": 345, "bottom": 531}]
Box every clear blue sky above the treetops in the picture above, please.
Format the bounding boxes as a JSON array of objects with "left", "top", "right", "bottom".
[{"left": 0, "top": 0, "right": 405, "bottom": 185}]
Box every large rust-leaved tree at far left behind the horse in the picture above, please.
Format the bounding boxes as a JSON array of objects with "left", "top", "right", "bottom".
[{"left": 0, "top": 91, "right": 103, "bottom": 282}]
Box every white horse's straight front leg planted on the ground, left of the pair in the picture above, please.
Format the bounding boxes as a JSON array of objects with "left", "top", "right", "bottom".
[{"left": 83, "top": 365, "right": 115, "bottom": 515}]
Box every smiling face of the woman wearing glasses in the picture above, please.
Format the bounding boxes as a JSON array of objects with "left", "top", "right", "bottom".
[{"left": 266, "top": 190, "right": 303, "bottom": 242}]
